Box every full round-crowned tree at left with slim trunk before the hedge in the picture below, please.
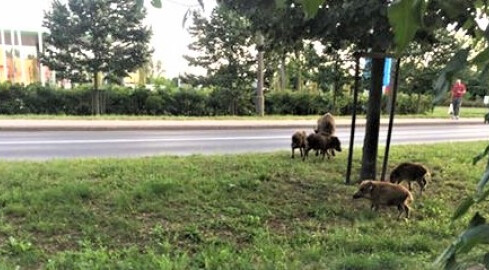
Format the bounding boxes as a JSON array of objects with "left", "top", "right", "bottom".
[{"left": 41, "top": 0, "right": 151, "bottom": 114}]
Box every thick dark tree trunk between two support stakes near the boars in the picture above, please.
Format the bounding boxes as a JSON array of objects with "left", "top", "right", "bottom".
[{"left": 360, "top": 58, "right": 384, "bottom": 180}]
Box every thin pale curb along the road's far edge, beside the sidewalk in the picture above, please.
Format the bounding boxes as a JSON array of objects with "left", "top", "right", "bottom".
[{"left": 0, "top": 119, "right": 483, "bottom": 132}]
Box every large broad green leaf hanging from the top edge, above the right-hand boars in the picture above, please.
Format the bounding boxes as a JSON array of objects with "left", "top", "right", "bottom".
[{"left": 388, "top": 0, "right": 426, "bottom": 52}]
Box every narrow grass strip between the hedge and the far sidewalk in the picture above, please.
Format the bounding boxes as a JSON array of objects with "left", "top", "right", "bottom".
[{"left": 0, "top": 107, "right": 489, "bottom": 121}]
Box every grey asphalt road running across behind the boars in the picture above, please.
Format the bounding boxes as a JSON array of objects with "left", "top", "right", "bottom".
[{"left": 0, "top": 123, "right": 489, "bottom": 160}]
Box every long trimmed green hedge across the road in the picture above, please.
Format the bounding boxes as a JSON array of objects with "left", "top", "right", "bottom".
[{"left": 0, "top": 84, "right": 432, "bottom": 116}]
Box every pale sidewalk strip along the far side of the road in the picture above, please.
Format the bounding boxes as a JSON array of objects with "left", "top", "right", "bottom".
[{"left": 0, "top": 118, "right": 483, "bottom": 131}]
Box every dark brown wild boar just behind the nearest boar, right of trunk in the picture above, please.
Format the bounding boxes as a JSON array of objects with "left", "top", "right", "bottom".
[{"left": 389, "top": 162, "right": 430, "bottom": 194}]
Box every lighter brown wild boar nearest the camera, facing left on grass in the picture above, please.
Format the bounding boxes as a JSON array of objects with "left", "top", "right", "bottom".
[{"left": 353, "top": 180, "right": 413, "bottom": 219}]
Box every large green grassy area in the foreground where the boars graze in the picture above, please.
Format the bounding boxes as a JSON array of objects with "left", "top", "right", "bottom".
[{"left": 0, "top": 142, "right": 487, "bottom": 269}]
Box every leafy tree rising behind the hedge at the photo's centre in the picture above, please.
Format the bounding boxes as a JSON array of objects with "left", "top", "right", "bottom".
[{"left": 184, "top": 6, "right": 255, "bottom": 114}]
